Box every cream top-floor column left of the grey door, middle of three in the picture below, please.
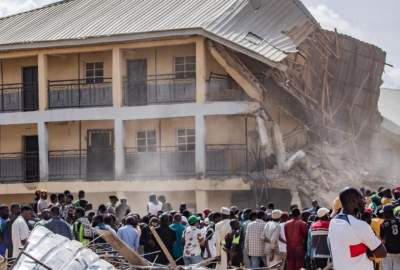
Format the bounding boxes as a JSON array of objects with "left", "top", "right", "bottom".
[{"left": 112, "top": 48, "right": 124, "bottom": 107}]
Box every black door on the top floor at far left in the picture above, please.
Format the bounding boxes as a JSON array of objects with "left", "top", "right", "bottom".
[{"left": 22, "top": 67, "right": 39, "bottom": 111}]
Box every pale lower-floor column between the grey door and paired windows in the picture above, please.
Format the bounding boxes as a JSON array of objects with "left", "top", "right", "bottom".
[{"left": 114, "top": 119, "right": 125, "bottom": 180}]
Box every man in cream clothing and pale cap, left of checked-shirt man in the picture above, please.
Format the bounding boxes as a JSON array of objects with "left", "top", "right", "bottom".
[{"left": 215, "top": 207, "right": 231, "bottom": 270}]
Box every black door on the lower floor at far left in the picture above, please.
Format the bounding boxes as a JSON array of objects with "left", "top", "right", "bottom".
[{"left": 24, "top": 136, "right": 39, "bottom": 183}]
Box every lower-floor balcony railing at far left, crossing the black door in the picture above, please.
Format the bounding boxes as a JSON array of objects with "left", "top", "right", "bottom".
[{"left": 0, "top": 152, "right": 39, "bottom": 183}]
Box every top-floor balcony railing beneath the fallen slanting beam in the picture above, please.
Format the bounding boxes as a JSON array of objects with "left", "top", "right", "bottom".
[{"left": 207, "top": 73, "right": 248, "bottom": 101}]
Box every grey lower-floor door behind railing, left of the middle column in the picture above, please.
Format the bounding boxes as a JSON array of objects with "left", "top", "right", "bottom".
[{"left": 87, "top": 129, "right": 114, "bottom": 180}]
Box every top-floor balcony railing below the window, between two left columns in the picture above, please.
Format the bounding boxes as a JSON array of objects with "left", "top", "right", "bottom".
[{"left": 48, "top": 78, "right": 113, "bottom": 109}]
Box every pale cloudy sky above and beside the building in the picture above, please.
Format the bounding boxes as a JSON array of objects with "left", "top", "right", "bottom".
[{"left": 0, "top": 0, "right": 400, "bottom": 89}]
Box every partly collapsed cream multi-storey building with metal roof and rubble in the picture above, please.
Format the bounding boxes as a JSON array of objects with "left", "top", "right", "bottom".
[{"left": 0, "top": 0, "right": 387, "bottom": 210}]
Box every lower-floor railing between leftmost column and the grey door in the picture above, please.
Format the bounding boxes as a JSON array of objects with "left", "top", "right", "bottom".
[{"left": 49, "top": 150, "right": 87, "bottom": 180}]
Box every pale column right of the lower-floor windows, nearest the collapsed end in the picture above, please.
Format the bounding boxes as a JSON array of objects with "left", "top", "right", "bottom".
[{"left": 195, "top": 115, "right": 206, "bottom": 176}]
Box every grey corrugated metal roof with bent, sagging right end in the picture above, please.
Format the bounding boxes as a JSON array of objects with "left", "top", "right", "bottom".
[{"left": 0, "top": 0, "right": 317, "bottom": 65}]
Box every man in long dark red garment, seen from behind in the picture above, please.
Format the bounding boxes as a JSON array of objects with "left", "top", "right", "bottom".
[{"left": 285, "top": 208, "right": 308, "bottom": 270}]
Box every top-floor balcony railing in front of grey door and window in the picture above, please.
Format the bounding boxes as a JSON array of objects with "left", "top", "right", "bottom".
[{"left": 124, "top": 74, "right": 196, "bottom": 106}]
